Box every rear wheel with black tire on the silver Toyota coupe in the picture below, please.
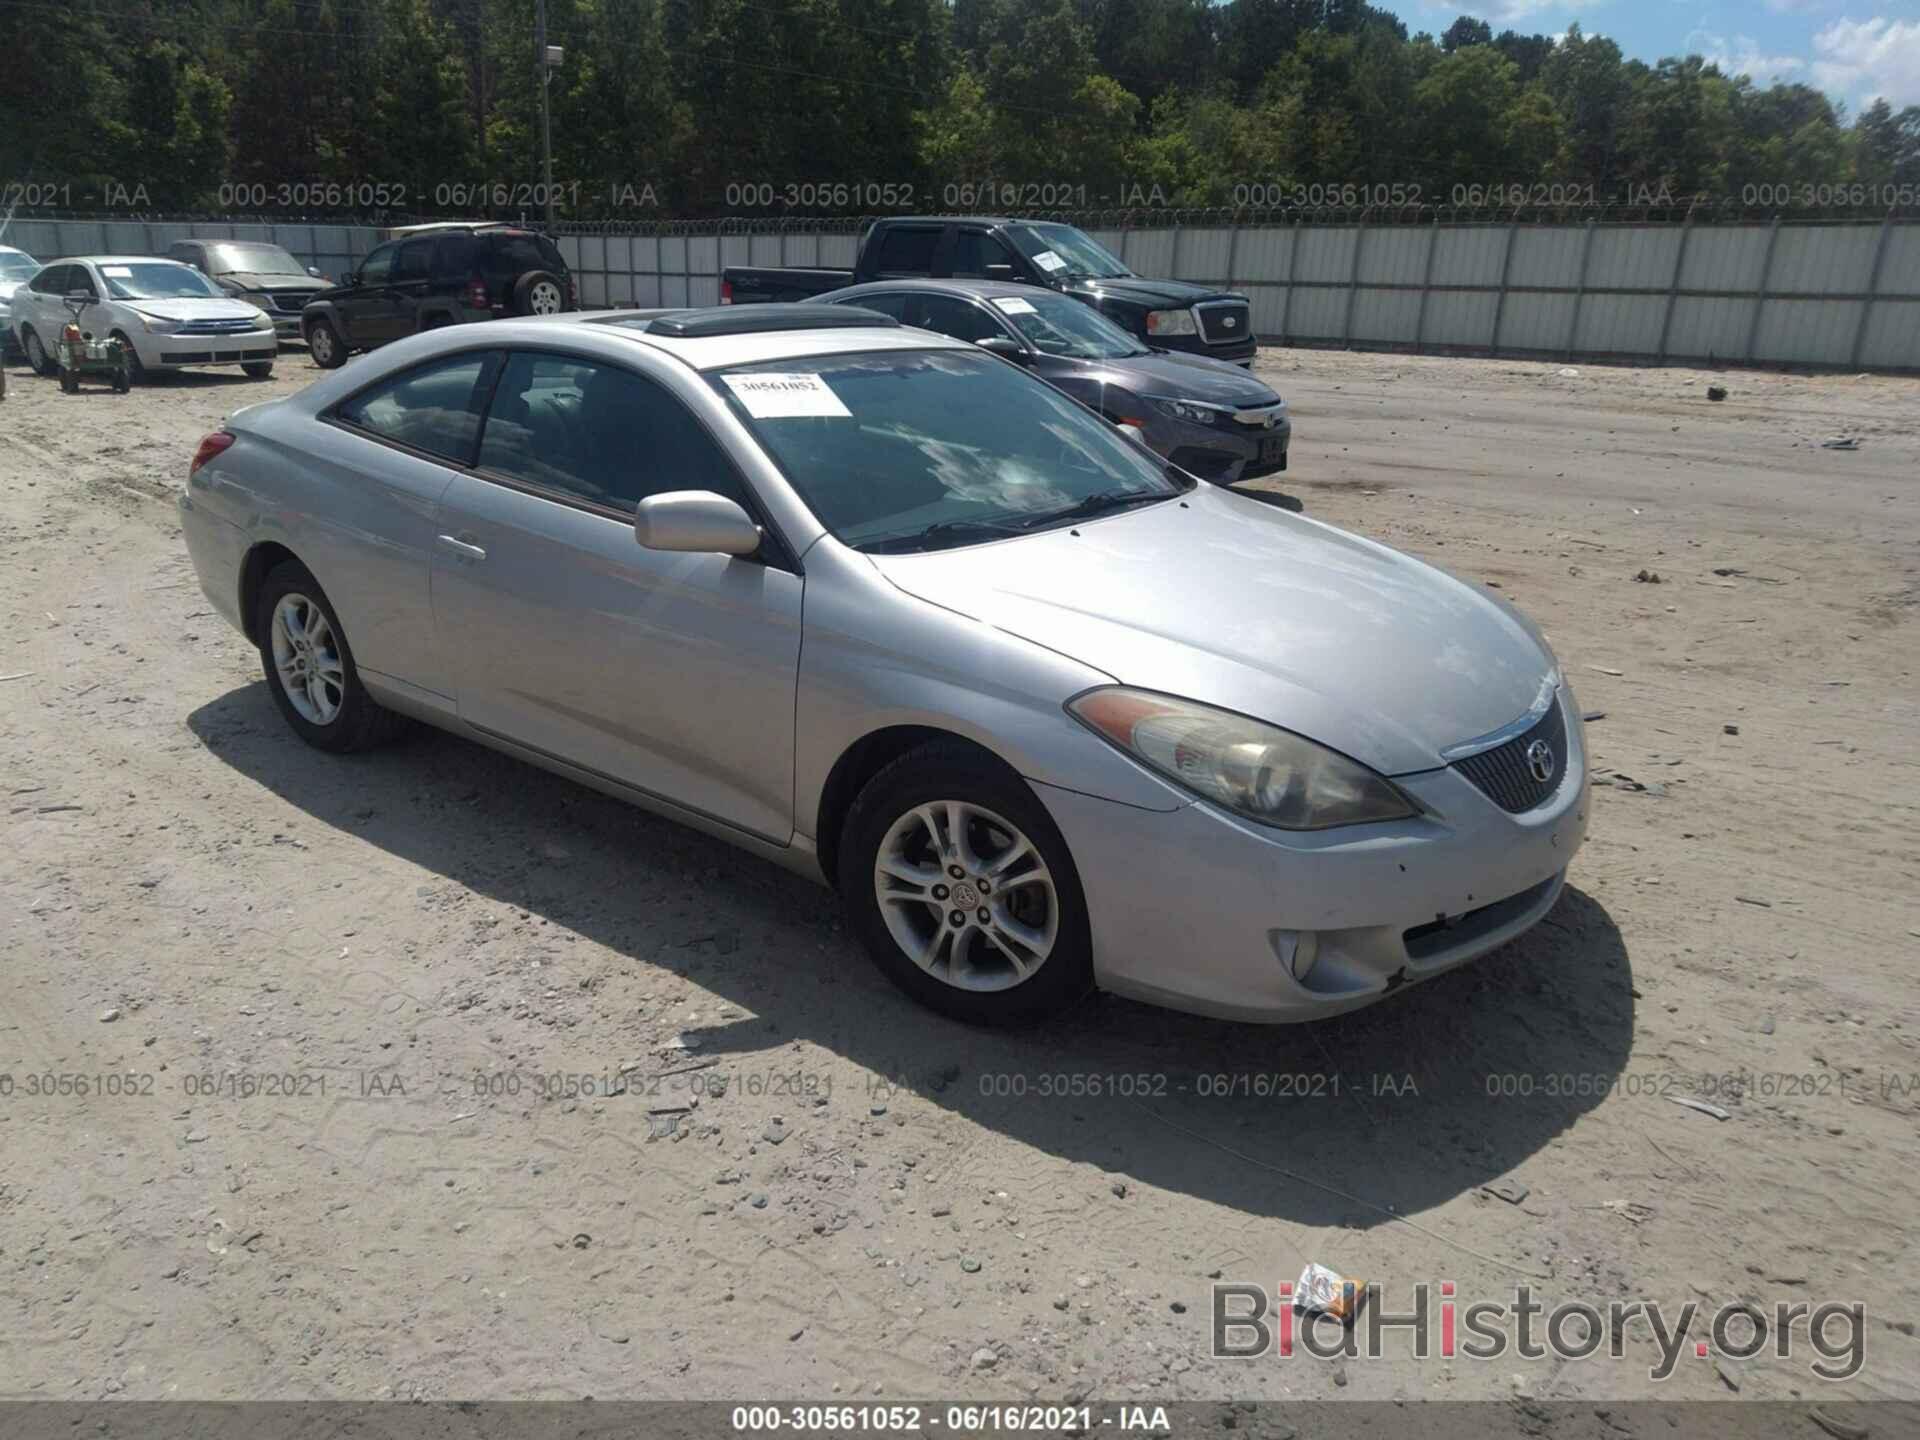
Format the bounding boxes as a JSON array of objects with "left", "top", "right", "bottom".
[{"left": 253, "top": 561, "right": 405, "bottom": 755}]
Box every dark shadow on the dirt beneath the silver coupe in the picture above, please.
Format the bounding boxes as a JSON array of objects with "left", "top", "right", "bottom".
[{"left": 188, "top": 682, "right": 1634, "bottom": 1229}]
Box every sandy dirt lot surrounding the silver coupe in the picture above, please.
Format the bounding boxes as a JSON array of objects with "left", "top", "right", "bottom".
[{"left": 0, "top": 351, "right": 1920, "bottom": 1413}]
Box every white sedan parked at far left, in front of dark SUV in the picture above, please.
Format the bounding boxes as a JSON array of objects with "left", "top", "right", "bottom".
[{"left": 13, "top": 255, "right": 280, "bottom": 382}]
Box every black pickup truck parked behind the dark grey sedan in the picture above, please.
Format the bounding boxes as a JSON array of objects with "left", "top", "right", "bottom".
[{"left": 720, "top": 215, "right": 1254, "bottom": 365}]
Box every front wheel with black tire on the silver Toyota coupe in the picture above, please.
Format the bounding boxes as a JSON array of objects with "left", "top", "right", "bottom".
[{"left": 839, "top": 741, "right": 1092, "bottom": 1025}]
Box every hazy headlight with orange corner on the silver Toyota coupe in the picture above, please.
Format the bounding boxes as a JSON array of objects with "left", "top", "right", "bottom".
[{"left": 1068, "top": 685, "right": 1419, "bottom": 829}]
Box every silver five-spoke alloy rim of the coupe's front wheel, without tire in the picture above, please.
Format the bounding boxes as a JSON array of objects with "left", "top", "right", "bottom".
[{"left": 874, "top": 801, "right": 1060, "bottom": 991}]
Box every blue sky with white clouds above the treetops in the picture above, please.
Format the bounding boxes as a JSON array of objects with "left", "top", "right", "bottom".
[{"left": 1397, "top": 0, "right": 1920, "bottom": 115}]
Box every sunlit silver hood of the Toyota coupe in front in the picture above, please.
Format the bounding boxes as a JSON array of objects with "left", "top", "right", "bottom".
[{"left": 868, "top": 486, "right": 1555, "bottom": 776}]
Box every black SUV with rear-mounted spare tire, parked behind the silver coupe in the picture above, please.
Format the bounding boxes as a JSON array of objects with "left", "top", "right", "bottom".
[{"left": 300, "top": 225, "right": 574, "bottom": 371}]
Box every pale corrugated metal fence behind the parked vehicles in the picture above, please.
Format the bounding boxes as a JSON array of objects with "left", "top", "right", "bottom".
[{"left": 6, "top": 217, "right": 1920, "bottom": 371}]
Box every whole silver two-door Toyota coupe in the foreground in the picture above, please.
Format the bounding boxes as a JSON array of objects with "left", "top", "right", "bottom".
[{"left": 180, "top": 305, "right": 1586, "bottom": 1023}]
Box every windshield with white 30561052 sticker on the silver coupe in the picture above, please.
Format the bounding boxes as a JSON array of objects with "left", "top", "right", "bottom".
[{"left": 708, "top": 349, "right": 1185, "bottom": 551}]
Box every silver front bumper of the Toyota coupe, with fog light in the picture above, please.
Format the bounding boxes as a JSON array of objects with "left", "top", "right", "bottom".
[{"left": 1035, "top": 689, "right": 1588, "bottom": 1023}]
